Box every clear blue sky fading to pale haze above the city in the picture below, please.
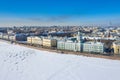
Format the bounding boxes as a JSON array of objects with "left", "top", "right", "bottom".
[{"left": 0, "top": 0, "right": 120, "bottom": 27}]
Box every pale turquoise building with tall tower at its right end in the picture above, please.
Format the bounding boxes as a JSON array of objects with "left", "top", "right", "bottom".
[{"left": 57, "top": 32, "right": 82, "bottom": 52}]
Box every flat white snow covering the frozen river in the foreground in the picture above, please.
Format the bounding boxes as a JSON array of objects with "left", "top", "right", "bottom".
[{"left": 0, "top": 42, "right": 120, "bottom": 80}]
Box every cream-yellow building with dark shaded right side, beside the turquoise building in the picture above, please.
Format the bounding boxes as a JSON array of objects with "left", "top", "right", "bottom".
[{"left": 43, "top": 38, "right": 57, "bottom": 47}]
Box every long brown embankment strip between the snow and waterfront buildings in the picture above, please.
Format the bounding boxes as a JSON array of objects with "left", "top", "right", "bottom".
[{"left": 0, "top": 40, "right": 120, "bottom": 60}]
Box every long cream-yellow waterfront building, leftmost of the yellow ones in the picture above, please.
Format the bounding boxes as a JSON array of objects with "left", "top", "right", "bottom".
[{"left": 27, "top": 36, "right": 42, "bottom": 45}]
